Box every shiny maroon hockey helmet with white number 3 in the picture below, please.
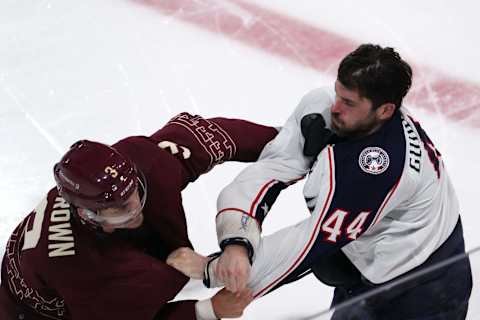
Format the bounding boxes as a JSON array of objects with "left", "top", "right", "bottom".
[{"left": 53, "top": 140, "right": 142, "bottom": 221}]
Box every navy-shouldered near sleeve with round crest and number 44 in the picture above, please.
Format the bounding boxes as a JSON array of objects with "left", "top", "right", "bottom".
[{"left": 207, "top": 114, "right": 411, "bottom": 297}]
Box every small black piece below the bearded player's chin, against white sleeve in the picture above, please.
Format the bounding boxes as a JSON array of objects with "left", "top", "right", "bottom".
[{"left": 300, "top": 113, "right": 335, "bottom": 157}]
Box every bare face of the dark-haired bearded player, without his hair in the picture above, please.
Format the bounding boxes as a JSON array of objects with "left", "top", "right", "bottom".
[{"left": 331, "top": 80, "right": 382, "bottom": 137}]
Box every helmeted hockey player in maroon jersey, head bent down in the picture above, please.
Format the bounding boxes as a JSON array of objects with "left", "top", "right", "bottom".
[{"left": 0, "top": 113, "right": 277, "bottom": 320}]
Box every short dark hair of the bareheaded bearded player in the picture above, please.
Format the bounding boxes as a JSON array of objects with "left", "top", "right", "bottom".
[{"left": 338, "top": 44, "right": 412, "bottom": 108}]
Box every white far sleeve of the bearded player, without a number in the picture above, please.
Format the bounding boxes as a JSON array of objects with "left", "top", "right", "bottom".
[{"left": 216, "top": 89, "right": 333, "bottom": 251}]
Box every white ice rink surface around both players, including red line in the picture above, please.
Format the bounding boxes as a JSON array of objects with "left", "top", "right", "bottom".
[{"left": 0, "top": 0, "right": 480, "bottom": 320}]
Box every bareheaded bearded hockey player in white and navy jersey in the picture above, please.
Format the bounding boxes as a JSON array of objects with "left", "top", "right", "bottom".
[{"left": 166, "top": 45, "right": 472, "bottom": 320}]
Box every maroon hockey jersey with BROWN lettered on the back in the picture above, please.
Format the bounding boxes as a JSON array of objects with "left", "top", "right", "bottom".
[{"left": 2, "top": 113, "right": 277, "bottom": 320}]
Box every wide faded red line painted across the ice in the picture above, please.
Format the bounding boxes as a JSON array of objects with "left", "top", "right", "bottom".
[{"left": 133, "top": 0, "right": 480, "bottom": 127}]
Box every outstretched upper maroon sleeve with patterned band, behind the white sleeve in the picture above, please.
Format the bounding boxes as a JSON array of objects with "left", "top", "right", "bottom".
[{"left": 150, "top": 112, "right": 278, "bottom": 183}]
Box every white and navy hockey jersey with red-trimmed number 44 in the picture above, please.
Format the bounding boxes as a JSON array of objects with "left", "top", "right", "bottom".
[{"left": 216, "top": 89, "right": 459, "bottom": 296}]
